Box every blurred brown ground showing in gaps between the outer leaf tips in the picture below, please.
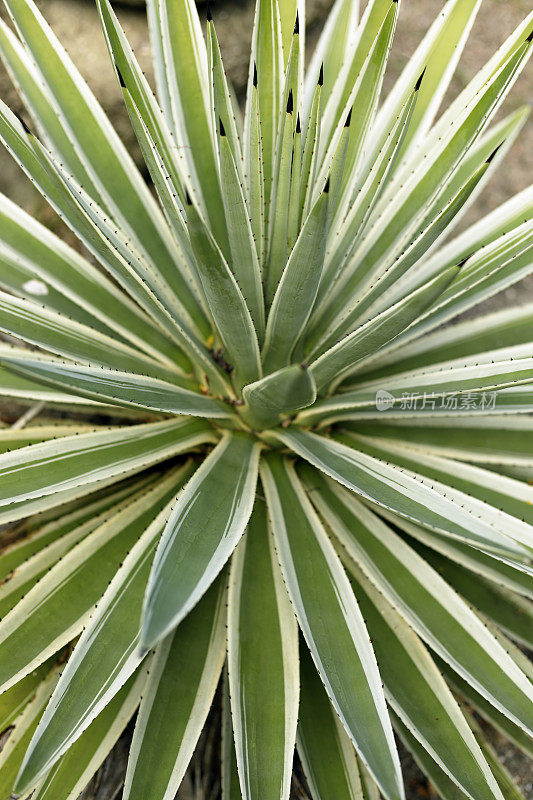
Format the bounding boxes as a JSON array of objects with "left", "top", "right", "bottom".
[{"left": 0, "top": 0, "right": 533, "bottom": 800}]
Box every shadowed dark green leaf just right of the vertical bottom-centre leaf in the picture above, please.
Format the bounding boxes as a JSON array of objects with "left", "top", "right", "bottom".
[{"left": 297, "top": 652, "right": 363, "bottom": 800}]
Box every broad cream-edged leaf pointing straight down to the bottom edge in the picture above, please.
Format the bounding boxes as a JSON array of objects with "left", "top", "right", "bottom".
[{"left": 228, "top": 499, "right": 299, "bottom": 800}]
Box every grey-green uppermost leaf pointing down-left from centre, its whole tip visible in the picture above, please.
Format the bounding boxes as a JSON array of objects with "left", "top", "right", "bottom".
[{"left": 142, "top": 434, "right": 261, "bottom": 648}]
